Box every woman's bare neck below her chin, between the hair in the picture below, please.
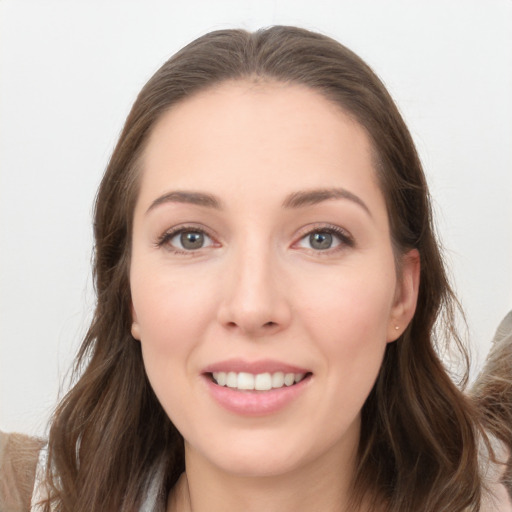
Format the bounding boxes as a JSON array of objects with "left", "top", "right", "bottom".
[{"left": 167, "top": 440, "right": 367, "bottom": 512}]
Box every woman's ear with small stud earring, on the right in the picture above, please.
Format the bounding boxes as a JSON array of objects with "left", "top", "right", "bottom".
[{"left": 387, "top": 249, "right": 421, "bottom": 343}]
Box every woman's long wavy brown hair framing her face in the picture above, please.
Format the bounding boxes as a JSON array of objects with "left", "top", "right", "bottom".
[{"left": 46, "top": 27, "right": 481, "bottom": 512}]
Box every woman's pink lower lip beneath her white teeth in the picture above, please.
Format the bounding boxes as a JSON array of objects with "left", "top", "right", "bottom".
[{"left": 204, "top": 375, "right": 311, "bottom": 416}]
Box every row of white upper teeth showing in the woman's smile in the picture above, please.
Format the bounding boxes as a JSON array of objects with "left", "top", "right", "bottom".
[{"left": 212, "top": 372, "right": 306, "bottom": 391}]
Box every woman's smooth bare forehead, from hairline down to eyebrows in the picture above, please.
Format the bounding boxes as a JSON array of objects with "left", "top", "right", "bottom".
[{"left": 136, "top": 81, "right": 384, "bottom": 214}]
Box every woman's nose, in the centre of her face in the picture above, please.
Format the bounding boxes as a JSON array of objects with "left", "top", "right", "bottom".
[{"left": 218, "top": 243, "right": 291, "bottom": 338}]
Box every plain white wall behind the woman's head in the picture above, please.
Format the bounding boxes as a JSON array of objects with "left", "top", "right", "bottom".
[{"left": 0, "top": 0, "right": 512, "bottom": 434}]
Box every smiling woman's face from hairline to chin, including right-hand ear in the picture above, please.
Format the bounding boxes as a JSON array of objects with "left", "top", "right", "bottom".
[{"left": 130, "top": 82, "right": 418, "bottom": 475}]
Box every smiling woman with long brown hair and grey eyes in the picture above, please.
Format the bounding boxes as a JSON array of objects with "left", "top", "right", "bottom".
[{"left": 3, "top": 27, "right": 508, "bottom": 512}]
